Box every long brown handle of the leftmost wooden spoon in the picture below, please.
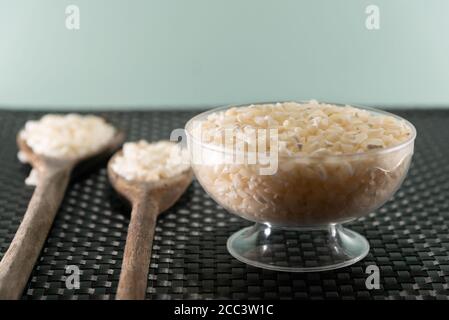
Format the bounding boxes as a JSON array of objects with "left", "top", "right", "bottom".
[{"left": 0, "top": 168, "right": 71, "bottom": 300}]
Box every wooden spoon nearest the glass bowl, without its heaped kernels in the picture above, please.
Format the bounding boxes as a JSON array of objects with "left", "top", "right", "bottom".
[{"left": 108, "top": 151, "right": 193, "bottom": 300}]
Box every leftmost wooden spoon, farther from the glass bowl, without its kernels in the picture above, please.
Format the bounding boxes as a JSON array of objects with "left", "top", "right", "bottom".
[{"left": 0, "top": 128, "right": 124, "bottom": 299}]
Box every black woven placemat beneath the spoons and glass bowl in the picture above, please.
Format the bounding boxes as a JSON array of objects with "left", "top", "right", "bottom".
[{"left": 0, "top": 110, "right": 449, "bottom": 299}]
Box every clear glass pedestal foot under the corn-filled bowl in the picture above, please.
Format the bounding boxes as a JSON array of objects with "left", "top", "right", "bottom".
[{"left": 227, "top": 223, "right": 369, "bottom": 272}]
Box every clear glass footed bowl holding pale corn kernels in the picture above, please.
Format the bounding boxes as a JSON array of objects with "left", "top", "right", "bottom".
[{"left": 186, "top": 104, "right": 416, "bottom": 272}]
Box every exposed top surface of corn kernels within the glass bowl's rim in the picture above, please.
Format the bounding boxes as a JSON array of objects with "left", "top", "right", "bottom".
[{"left": 201, "top": 100, "right": 411, "bottom": 155}]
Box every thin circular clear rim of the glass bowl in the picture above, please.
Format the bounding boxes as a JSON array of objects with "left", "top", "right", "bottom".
[{"left": 184, "top": 100, "right": 417, "bottom": 160}]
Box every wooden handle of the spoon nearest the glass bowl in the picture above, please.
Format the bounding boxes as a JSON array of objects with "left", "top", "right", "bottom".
[{"left": 116, "top": 199, "right": 158, "bottom": 300}]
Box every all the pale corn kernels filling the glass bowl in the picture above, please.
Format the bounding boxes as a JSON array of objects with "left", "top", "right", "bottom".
[{"left": 187, "top": 101, "right": 413, "bottom": 226}]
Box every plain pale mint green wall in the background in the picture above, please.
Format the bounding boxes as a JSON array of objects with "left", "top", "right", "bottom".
[{"left": 0, "top": 0, "right": 449, "bottom": 109}]
